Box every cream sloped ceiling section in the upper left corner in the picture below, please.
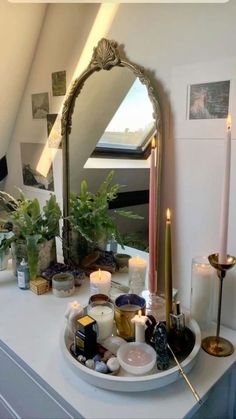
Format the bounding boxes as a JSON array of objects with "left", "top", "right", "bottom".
[{"left": 0, "top": 0, "right": 47, "bottom": 158}]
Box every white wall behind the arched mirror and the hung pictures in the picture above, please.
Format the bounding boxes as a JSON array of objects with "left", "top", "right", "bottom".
[{"left": 7, "top": 1, "right": 236, "bottom": 327}]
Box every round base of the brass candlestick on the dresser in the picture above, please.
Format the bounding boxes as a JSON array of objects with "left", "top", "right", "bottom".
[{"left": 202, "top": 336, "right": 234, "bottom": 357}]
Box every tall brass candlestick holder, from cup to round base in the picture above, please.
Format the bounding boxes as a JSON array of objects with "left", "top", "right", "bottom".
[{"left": 202, "top": 253, "right": 236, "bottom": 357}]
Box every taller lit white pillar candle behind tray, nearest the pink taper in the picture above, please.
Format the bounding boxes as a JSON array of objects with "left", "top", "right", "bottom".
[{"left": 129, "top": 256, "right": 147, "bottom": 294}]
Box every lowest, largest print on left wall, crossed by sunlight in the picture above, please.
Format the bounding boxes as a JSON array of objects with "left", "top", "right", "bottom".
[{"left": 20, "top": 143, "right": 54, "bottom": 191}]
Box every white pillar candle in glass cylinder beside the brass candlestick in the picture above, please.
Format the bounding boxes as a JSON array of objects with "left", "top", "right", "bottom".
[{"left": 190, "top": 256, "right": 214, "bottom": 330}]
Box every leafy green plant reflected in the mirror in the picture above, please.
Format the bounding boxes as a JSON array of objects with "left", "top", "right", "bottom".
[{"left": 68, "top": 171, "right": 142, "bottom": 263}]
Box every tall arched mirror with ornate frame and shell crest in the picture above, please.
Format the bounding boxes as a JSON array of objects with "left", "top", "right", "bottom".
[{"left": 62, "top": 40, "right": 161, "bottom": 270}]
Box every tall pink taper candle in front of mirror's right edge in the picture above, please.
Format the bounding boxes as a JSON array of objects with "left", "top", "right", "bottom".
[{"left": 148, "top": 138, "right": 156, "bottom": 293}]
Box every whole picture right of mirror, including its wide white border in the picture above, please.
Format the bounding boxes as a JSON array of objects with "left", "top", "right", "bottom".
[{"left": 170, "top": 58, "right": 236, "bottom": 139}]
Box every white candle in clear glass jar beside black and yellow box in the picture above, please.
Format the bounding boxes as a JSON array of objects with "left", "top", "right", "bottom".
[{"left": 87, "top": 303, "right": 114, "bottom": 341}]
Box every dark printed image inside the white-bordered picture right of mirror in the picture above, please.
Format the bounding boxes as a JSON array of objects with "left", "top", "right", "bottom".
[{"left": 188, "top": 80, "right": 230, "bottom": 119}]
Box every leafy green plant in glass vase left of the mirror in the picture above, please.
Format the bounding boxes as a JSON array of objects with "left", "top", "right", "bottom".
[{"left": 0, "top": 190, "right": 61, "bottom": 279}]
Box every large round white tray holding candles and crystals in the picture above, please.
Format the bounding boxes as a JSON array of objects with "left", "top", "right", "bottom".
[{"left": 60, "top": 319, "right": 201, "bottom": 392}]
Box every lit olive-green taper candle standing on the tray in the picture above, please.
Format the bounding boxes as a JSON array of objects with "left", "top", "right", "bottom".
[{"left": 165, "top": 208, "right": 172, "bottom": 332}]
